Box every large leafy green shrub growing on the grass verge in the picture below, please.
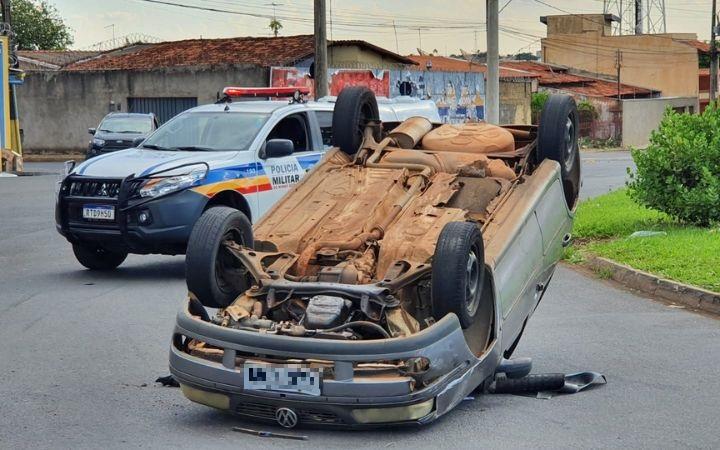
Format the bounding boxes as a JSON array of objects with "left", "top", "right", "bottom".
[{"left": 628, "top": 104, "right": 720, "bottom": 226}]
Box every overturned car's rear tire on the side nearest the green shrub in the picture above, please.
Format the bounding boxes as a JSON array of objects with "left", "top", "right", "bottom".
[{"left": 537, "top": 95, "right": 580, "bottom": 209}]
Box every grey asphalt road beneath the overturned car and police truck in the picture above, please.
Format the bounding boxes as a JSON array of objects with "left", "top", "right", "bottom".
[{"left": 0, "top": 153, "right": 720, "bottom": 449}]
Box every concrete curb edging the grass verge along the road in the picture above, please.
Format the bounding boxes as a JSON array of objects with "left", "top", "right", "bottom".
[{"left": 585, "top": 256, "right": 720, "bottom": 315}]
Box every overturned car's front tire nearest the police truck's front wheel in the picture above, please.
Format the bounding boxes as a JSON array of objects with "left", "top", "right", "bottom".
[{"left": 185, "top": 206, "right": 253, "bottom": 308}]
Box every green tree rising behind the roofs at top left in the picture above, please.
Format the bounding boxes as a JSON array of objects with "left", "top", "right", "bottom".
[{"left": 10, "top": 0, "right": 74, "bottom": 50}]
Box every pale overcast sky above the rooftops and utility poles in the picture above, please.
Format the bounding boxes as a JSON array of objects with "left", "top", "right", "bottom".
[{"left": 49, "top": 0, "right": 712, "bottom": 54}]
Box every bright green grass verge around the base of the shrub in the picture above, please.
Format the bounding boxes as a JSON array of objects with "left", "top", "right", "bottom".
[{"left": 566, "top": 189, "right": 720, "bottom": 292}]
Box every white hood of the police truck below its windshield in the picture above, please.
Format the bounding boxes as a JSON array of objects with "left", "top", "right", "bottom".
[{"left": 72, "top": 148, "right": 240, "bottom": 178}]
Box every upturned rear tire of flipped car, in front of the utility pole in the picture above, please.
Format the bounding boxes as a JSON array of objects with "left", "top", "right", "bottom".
[{"left": 332, "top": 86, "right": 380, "bottom": 155}]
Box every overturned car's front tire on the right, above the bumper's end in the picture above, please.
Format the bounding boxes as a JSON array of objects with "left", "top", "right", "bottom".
[{"left": 432, "top": 222, "right": 485, "bottom": 328}]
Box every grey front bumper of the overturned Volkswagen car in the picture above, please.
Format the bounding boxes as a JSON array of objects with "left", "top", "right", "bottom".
[{"left": 170, "top": 300, "right": 501, "bottom": 428}]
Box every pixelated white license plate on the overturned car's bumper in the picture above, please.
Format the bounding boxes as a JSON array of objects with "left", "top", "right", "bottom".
[{"left": 243, "top": 364, "right": 320, "bottom": 396}]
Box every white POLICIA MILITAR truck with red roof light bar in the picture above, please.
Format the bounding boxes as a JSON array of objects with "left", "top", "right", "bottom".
[{"left": 55, "top": 88, "right": 440, "bottom": 270}]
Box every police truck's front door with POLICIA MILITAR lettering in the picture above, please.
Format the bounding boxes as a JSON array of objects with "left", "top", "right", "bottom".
[{"left": 258, "top": 111, "right": 323, "bottom": 218}]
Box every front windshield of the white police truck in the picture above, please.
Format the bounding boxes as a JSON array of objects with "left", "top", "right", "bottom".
[{"left": 142, "top": 111, "right": 270, "bottom": 151}]
